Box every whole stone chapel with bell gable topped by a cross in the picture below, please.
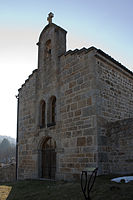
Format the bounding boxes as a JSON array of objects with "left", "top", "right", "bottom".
[{"left": 17, "top": 13, "right": 133, "bottom": 180}]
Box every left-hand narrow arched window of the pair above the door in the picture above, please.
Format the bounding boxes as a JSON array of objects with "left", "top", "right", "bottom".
[{"left": 40, "top": 100, "right": 46, "bottom": 128}]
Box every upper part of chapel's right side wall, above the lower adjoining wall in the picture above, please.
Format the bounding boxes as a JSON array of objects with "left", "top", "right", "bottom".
[{"left": 96, "top": 57, "right": 133, "bottom": 121}]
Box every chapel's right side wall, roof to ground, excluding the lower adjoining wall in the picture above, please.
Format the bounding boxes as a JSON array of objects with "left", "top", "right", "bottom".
[{"left": 96, "top": 55, "right": 133, "bottom": 174}]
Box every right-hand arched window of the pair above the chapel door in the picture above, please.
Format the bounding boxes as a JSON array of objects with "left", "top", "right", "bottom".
[{"left": 48, "top": 96, "right": 56, "bottom": 127}]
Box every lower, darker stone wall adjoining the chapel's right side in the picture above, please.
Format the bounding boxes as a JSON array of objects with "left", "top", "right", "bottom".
[{"left": 107, "top": 118, "right": 133, "bottom": 174}]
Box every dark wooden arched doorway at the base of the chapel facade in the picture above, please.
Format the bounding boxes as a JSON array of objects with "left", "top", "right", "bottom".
[{"left": 41, "top": 137, "right": 56, "bottom": 179}]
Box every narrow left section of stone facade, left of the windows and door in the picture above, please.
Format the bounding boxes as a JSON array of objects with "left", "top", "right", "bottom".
[{"left": 18, "top": 71, "right": 37, "bottom": 178}]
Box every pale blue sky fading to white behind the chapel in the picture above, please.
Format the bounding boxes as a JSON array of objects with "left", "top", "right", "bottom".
[{"left": 0, "top": 0, "right": 133, "bottom": 138}]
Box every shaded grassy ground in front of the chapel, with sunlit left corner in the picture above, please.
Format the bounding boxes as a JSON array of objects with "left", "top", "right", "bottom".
[{"left": 0, "top": 176, "right": 133, "bottom": 200}]
